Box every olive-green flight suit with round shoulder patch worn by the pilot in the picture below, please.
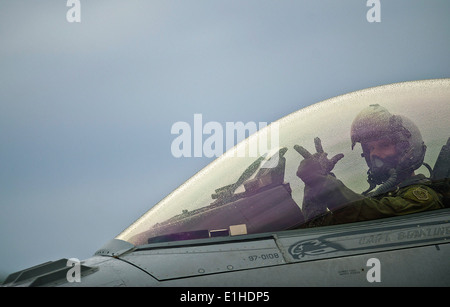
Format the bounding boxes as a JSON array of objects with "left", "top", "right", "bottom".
[{"left": 303, "top": 175, "right": 449, "bottom": 227}]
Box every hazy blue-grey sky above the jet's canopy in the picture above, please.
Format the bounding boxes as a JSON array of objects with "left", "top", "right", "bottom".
[{"left": 0, "top": 0, "right": 450, "bottom": 278}]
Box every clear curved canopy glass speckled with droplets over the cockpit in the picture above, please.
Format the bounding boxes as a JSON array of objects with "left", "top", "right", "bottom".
[{"left": 116, "top": 79, "right": 450, "bottom": 245}]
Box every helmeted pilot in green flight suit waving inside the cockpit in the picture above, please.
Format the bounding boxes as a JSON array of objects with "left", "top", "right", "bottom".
[{"left": 296, "top": 104, "right": 444, "bottom": 227}]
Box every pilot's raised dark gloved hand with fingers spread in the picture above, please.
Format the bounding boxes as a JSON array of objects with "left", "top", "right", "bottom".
[{"left": 294, "top": 137, "right": 344, "bottom": 186}]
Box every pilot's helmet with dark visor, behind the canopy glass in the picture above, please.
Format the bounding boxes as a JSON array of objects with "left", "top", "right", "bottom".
[{"left": 351, "top": 104, "right": 426, "bottom": 184}]
